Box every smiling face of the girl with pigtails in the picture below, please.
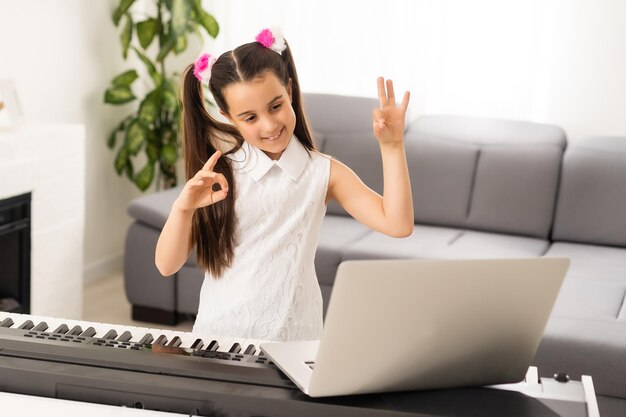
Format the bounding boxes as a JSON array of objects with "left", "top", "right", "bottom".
[{"left": 222, "top": 71, "right": 296, "bottom": 160}]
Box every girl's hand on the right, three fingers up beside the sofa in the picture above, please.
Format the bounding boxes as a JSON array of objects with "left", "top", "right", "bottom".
[{"left": 373, "top": 77, "right": 410, "bottom": 145}]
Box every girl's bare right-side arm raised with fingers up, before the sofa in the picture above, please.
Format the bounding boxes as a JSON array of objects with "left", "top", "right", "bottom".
[{"left": 327, "top": 77, "right": 414, "bottom": 237}]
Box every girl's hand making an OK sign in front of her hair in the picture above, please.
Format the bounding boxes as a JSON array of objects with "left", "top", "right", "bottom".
[{"left": 176, "top": 151, "right": 228, "bottom": 211}]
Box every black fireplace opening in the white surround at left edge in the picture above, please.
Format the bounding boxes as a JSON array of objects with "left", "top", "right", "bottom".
[{"left": 0, "top": 193, "right": 31, "bottom": 314}]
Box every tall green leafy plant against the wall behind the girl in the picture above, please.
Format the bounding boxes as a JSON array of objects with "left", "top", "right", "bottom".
[{"left": 104, "top": 0, "right": 219, "bottom": 191}]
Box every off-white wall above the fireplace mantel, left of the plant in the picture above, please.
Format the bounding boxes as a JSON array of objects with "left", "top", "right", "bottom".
[{"left": 0, "top": 0, "right": 139, "bottom": 278}]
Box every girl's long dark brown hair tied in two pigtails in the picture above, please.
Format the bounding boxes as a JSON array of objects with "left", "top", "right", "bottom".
[{"left": 181, "top": 42, "right": 315, "bottom": 278}]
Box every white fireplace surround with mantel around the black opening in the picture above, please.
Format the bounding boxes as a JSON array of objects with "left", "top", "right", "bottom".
[{"left": 0, "top": 124, "right": 85, "bottom": 319}]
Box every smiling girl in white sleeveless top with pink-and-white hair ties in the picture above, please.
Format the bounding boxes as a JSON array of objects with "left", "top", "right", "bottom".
[{"left": 156, "top": 29, "right": 413, "bottom": 340}]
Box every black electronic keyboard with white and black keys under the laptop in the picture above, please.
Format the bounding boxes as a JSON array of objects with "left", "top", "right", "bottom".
[{"left": 0, "top": 312, "right": 595, "bottom": 417}]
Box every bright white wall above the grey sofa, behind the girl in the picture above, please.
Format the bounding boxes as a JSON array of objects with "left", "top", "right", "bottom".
[{"left": 208, "top": 0, "right": 626, "bottom": 138}]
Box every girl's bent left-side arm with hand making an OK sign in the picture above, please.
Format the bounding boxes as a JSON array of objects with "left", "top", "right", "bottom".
[{"left": 154, "top": 151, "right": 228, "bottom": 276}]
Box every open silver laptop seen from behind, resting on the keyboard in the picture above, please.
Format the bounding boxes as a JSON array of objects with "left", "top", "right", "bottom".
[{"left": 261, "top": 258, "right": 569, "bottom": 397}]
